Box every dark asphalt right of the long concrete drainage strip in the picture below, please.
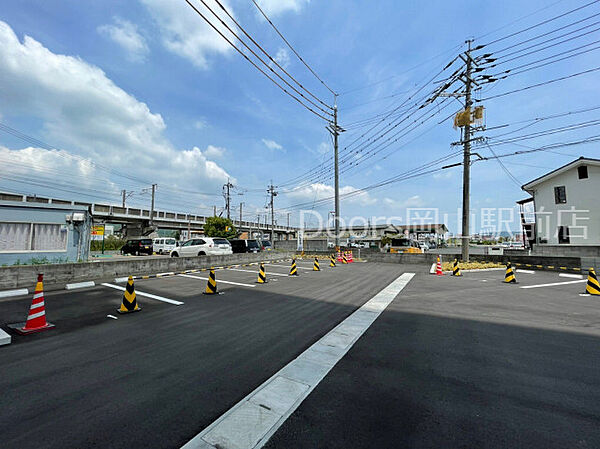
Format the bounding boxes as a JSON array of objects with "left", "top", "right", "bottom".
[{"left": 266, "top": 272, "right": 600, "bottom": 449}]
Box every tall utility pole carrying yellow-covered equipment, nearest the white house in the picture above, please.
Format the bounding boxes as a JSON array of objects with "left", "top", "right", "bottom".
[{"left": 461, "top": 39, "right": 473, "bottom": 262}]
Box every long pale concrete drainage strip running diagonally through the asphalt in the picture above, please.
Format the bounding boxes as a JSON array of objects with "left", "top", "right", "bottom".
[{"left": 183, "top": 273, "right": 415, "bottom": 449}]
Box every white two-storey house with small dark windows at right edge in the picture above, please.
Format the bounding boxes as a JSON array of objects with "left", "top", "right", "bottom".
[{"left": 517, "top": 157, "right": 600, "bottom": 247}]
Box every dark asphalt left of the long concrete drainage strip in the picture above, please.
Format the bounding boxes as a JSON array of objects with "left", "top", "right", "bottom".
[{"left": 0, "top": 262, "right": 403, "bottom": 449}]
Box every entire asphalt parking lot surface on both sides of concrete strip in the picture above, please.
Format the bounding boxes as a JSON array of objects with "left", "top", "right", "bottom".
[{"left": 0, "top": 261, "right": 600, "bottom": 448}]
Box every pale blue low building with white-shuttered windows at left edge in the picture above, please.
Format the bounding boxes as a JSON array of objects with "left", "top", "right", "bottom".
[{"left": 0, "top": 192, "right": 92, "bottom": 265}]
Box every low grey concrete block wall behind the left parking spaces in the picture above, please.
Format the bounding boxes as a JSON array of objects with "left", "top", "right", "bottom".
[{"left": 0, "top": 251, "right": 293, "bottom": 290}]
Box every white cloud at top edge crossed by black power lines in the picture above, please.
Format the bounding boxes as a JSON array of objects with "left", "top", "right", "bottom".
[{"left": 140, "top": 0, "right": 235, "bottom": 69}]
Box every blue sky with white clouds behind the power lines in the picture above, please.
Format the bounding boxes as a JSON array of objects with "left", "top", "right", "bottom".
[{"left": 0, "top": 0, "right": 600, "bottom": 231}]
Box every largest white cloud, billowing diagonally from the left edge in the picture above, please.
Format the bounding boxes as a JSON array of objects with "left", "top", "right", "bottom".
[{"left": 0, "top": 21, "right": 228, "bottom": 195}]
